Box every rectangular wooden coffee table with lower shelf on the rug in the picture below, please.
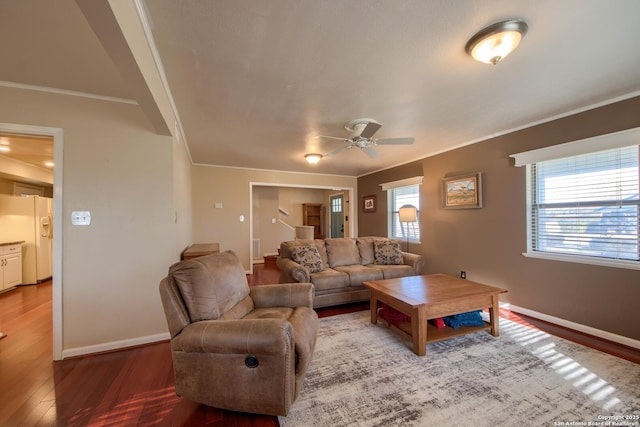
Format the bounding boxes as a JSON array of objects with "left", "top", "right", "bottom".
[{"left": 363, "top": 274, "right": 507, "bottom": 356}]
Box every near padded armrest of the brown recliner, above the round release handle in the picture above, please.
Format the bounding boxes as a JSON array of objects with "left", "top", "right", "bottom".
[{"left": 171, "top": 319, "right": 294, "bottom": 355}]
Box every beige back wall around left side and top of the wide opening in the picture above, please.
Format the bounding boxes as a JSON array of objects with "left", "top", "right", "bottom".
[{"left": 192, "top": 165, "right": 357, "bottom": 271}]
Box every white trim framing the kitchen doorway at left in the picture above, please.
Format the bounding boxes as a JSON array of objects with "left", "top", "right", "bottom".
[{"left": 0, "top": 123, "right": 64, "bottom": 360}]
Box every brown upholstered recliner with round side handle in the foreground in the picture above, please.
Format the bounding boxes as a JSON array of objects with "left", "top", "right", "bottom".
[{"left": 160, "top": 251, "right": 318, "bottom": 415}]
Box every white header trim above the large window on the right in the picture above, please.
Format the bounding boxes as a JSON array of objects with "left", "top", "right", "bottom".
[{"left": 509, "top": 127, "right": 640, "bottom": 166}]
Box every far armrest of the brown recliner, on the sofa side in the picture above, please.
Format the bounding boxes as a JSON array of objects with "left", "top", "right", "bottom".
[{"left": 250, "top": 283, "right": 315, "bottom": 308}]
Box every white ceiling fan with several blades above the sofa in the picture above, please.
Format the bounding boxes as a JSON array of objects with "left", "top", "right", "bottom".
[{"left": 318, "top": 119, "right": 414, "bottom": 159}]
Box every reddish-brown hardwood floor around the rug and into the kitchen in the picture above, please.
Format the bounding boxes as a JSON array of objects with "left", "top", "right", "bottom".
[{"left": 0, "top": 266, "right": 640, "bottom": 427}]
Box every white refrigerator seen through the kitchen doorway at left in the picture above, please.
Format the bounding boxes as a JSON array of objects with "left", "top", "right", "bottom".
[{"left": 0, "top": 195, "right": 53, "bottom": 285}]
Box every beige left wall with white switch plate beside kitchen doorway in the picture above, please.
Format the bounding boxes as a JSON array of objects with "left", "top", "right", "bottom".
[{"left": 0, "top": 87, "right": 191, "bottom": 354}]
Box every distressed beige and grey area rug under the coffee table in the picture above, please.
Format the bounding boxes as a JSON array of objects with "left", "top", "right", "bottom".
[{"left": 279, "top": 311, "right": 640, "bottom": 427}]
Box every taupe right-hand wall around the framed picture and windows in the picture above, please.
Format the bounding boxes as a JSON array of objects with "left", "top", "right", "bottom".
[{"left": 358, "top": 98, "right": 640, "bottom": 340}]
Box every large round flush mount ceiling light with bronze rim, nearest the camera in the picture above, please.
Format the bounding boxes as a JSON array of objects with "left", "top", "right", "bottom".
[{"left": 465, "top": 20, "right": 529, "bottom": 65}]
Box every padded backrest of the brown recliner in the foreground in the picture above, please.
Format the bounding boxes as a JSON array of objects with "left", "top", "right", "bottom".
[{"left": 169, "top": 251, "right": 249, "bottom": 322}]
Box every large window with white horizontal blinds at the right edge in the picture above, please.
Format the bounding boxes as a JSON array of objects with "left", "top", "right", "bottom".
[{"left": 527, "top": 145, "right": 640, "bottom": 261}]
